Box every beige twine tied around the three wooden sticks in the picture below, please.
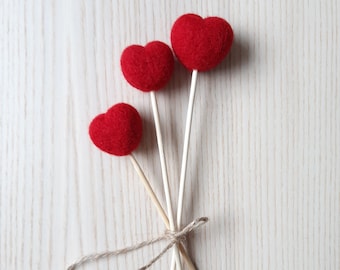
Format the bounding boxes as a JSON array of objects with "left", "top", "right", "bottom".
[{"left": 67, "top": 217, "right": 208, "bottom": 270}]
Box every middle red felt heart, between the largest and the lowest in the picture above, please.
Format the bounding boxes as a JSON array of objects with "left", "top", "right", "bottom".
[{"left": 120, "top": 41, "right": 174, "bottom": 92}]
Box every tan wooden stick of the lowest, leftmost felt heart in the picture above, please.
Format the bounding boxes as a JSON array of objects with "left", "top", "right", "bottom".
[{"left": 129, "top": 154, "right": 196, "bottom": 270}]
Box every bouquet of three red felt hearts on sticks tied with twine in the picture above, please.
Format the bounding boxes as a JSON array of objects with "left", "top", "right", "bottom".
[{"left": 69, "top": 14, "right": 233, "bottom": 270}]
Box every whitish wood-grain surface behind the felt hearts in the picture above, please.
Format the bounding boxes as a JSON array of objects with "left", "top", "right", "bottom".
[{"left": 0, "top": 0, "right": 340, "bottom": 270}]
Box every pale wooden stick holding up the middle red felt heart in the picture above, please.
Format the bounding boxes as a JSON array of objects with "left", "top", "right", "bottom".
[{"left": 150, "top": 91, "right": 182, "bottom": 270}]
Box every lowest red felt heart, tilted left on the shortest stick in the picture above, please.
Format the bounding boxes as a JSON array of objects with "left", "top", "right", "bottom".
[{"left": 89, "top": 103, "right": 143, "bottom": 156}]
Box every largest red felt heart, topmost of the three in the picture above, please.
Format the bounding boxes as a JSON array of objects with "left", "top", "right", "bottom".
[{"left": 171, "top": 14, "right": 234, "bottom": 71}]
